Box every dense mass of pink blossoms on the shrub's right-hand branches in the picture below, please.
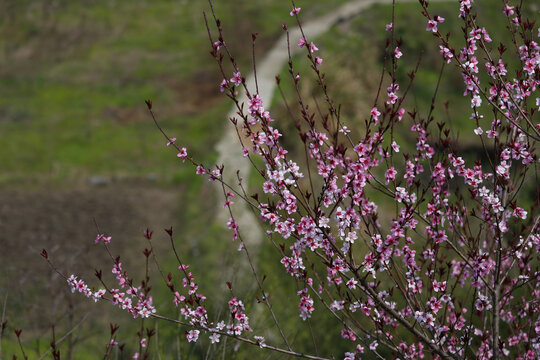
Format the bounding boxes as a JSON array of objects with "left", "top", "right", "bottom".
[{"left": 194, "top": 0, "right": 540, "bottom": 358}]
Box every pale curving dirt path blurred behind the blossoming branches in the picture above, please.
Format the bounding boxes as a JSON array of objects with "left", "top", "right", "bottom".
[{"left": 216, "top": 0, "right": 392, "bottom": 249}]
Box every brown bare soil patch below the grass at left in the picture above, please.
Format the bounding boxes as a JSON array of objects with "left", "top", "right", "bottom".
[{"left": 0, "top": 182, "right": 182, "bottom": 332}]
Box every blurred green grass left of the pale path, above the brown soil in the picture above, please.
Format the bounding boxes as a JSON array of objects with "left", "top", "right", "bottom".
[{"left": 0, "top": 0, "right": 350, "bottom": 184}]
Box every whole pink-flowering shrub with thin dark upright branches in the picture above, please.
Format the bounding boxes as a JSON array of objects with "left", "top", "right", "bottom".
[{"left": 31, "top": 0, "right": 540, "bottom": 359}]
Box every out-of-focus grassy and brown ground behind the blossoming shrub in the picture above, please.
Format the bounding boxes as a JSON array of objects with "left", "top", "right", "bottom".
[{"left": 0, "top": 0, "right": 532, "bottom": 359}]
